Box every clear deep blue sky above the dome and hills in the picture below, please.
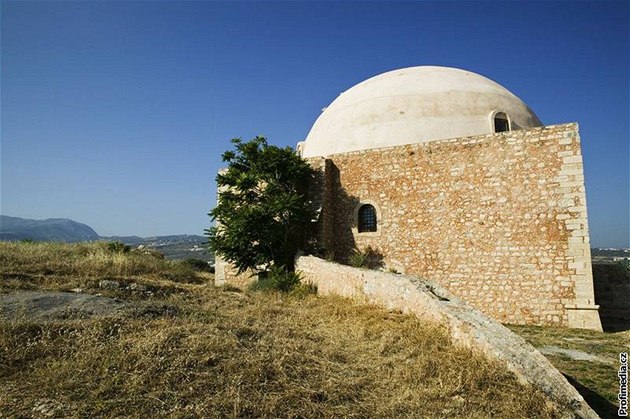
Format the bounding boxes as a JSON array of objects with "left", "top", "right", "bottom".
[{"left": 0, "top": 1, "right": 630, "bottom": 247}]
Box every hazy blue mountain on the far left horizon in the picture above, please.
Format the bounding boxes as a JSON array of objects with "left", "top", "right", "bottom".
[{"left": 0, "top": 215, "right": 99, "bottom": 243}]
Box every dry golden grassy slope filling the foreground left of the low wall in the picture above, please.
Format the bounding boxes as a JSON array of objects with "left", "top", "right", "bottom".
[{"left": 0, "top": 243, "right": 555, "bottom": 417}]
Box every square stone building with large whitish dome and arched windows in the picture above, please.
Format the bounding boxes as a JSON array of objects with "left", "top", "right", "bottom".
[{"left": 217, "top": 67, "right": 601, "bottom": 329}]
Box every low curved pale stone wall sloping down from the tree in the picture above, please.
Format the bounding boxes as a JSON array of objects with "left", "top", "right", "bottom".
[{"left": 296, "top": 256, "right": 598, "bottom": 418}]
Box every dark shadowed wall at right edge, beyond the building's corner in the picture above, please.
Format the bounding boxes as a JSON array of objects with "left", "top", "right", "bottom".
[{"left": 593, "top": 263, "right": 630, "bottom": 332}]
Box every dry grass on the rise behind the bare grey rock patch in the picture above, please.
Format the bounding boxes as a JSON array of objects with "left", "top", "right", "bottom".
[{"left": 0, "top": 242, "right": 205, "bottom": 298}]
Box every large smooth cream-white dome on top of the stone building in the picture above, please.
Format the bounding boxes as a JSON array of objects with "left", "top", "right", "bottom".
[{"left": 298, "top": 66, "right": 542, "bottom": 157}]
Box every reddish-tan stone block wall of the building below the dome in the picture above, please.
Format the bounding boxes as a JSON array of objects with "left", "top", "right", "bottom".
[{"left": 320, "top": 124, "right": 601, "bottom": 329}]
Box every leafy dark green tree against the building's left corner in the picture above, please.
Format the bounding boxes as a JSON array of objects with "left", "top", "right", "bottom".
[{"left": 206, "top": 137, "right": 314, "bottom": 273}]
